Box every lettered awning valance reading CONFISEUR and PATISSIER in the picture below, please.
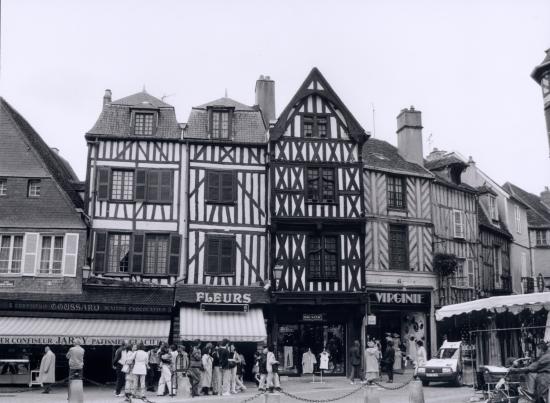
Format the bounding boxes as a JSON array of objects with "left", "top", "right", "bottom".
[{"left": 0, "top": 336, "right": 167, "bottom": 346}]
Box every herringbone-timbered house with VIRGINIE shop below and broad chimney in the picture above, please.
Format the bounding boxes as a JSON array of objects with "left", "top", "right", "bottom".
[{"left": 363, "top": 107, "right": 438, "bottom": 352}]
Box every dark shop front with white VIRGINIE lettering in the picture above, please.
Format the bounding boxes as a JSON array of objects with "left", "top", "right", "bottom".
[{"left": 365, "top": 289, "right": 432, "bottom": 364}]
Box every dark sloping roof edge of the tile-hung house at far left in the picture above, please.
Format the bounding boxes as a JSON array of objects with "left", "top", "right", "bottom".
[{"left": 0, "top": 98, "right": 84, "bottom": 208}]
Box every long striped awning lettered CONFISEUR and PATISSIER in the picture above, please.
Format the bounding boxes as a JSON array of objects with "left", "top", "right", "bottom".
[{"left": 0, "top": 317, "right": 170, "bottom": 346}]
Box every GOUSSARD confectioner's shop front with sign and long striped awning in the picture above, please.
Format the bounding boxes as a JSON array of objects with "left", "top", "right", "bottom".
[{"left": 0, "top": 287, "right": 173, "bottom": 383}]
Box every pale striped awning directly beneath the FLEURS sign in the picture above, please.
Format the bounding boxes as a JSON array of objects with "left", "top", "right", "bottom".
[{"left": 180, "top": 307, "right": 267, "bottom": 342}]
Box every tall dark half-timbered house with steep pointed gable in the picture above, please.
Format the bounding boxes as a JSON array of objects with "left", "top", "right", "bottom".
[{"left": 268, "top": 68, "right": 368, "bottom": 375}]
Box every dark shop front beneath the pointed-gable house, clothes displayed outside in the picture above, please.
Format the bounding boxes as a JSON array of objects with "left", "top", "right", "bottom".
[{"left": 270, "top": 293, "right": 365, "bottom": 376}]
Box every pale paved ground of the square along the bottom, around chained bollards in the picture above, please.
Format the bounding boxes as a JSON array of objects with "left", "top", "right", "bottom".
[{"left": 0, "top": 376, "right": 484, "bottom": 403}]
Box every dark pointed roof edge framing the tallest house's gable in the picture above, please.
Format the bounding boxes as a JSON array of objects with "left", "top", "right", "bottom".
[{"left": 270, "top": 67, "right": 369, "bottom": 144}]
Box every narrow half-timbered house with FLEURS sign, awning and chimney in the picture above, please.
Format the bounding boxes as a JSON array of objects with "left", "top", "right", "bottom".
[{"left": 173, "top": 77, "right": 275, "bottom": 348}]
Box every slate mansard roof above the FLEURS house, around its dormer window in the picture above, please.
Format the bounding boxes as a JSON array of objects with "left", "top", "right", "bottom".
[{"left": 184, "top": 97, "right": 267, "bottom": 144}]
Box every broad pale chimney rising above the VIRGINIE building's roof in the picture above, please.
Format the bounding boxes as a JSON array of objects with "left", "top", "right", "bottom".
[{"left": 397, "top": 106, "right": 424, "bottom": 165}]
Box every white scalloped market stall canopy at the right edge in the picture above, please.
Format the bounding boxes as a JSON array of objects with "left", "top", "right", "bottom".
[{"left": 435, "top": 292, "right": 550, "bottom": 320}]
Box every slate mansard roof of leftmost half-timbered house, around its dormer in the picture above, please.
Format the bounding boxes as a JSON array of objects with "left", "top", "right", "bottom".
[{"left": 87, "top": 91, "right": 181, "bottom": 139}]
